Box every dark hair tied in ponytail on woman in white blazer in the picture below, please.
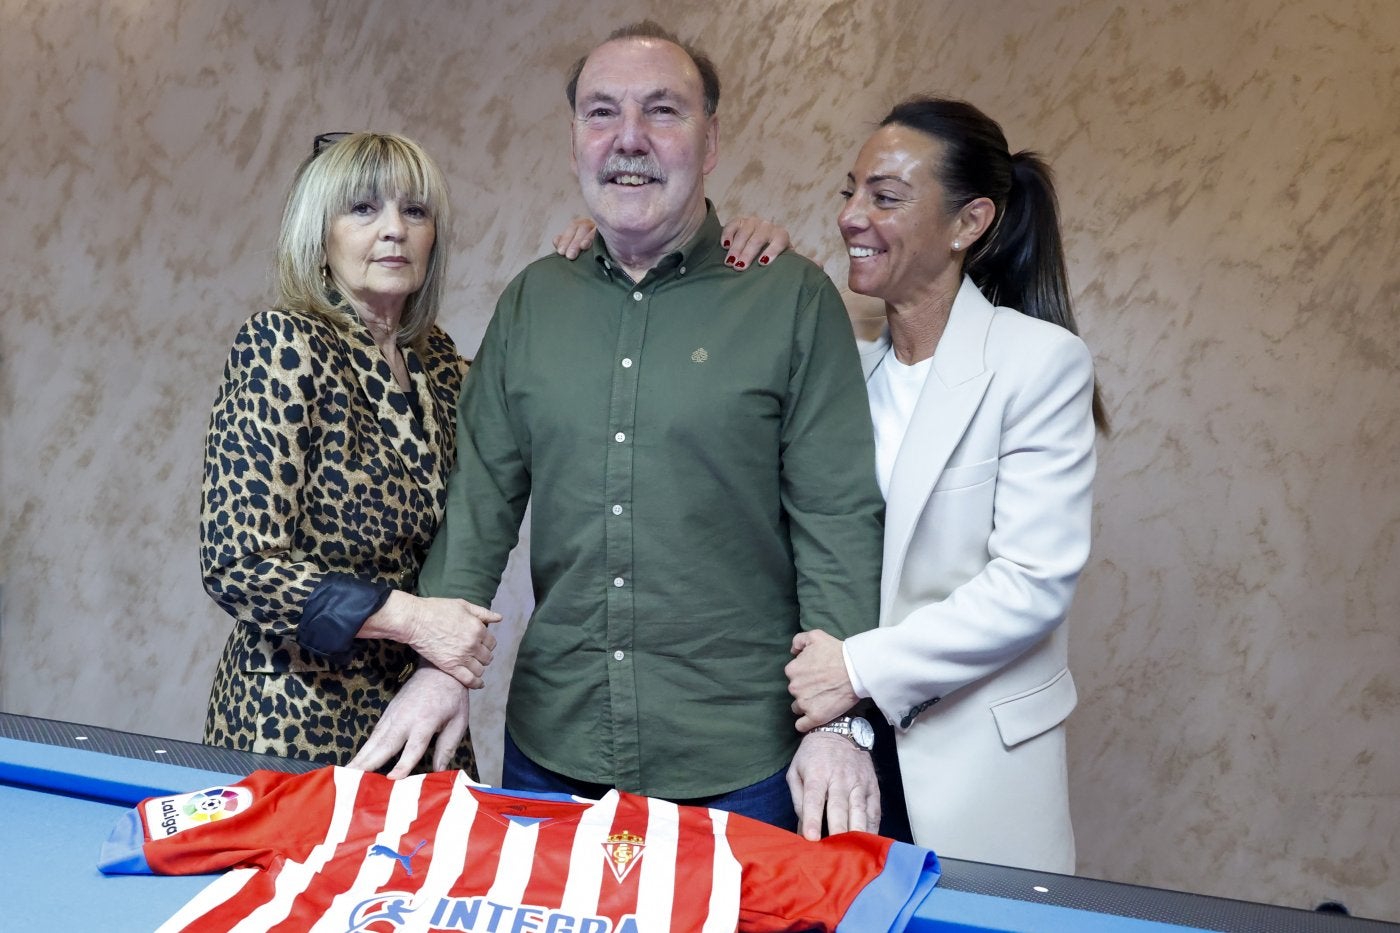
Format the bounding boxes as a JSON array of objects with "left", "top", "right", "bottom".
[{"left": 881, "top": 97, "right": 1109, "bottom": 434}]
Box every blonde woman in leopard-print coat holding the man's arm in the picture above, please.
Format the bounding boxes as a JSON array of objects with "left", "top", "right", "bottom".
[{"left": 200, "top": 133, "right": 498, "bottom": 772}]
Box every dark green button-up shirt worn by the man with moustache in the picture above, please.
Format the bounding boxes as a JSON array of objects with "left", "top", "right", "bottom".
[{"left": 420, "top": 209, "right": 883, "bottom": 799}]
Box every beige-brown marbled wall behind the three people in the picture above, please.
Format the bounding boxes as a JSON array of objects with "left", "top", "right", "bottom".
[{"left": 0, "top": 0, "right": 1400, "bottom": 919}]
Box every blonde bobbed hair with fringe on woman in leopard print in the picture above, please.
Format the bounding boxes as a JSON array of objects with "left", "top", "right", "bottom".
[{"left": 277, "top": 133, "right": 451, "bottom": 346}]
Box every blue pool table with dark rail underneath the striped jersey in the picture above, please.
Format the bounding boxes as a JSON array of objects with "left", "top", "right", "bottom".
[{"left": 0, "top": 713, "right": 1400, "bottom": 933}]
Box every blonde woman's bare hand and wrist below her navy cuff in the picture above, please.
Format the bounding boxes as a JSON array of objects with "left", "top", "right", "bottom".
[{"left": 357, "top": 590, "right": 501, "bottom": 689}]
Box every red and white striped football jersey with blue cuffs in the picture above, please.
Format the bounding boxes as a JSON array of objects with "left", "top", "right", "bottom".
[{"left": 98, "top": 768, "right": 938, "bottom": 933}]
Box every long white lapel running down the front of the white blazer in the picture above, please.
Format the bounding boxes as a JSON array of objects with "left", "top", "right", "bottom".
[{"left": 861, "top": 276, "right": 993, "bottom": 615}]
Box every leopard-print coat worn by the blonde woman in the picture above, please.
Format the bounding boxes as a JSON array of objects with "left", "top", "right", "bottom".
[{"left": 200, "top": 308, "right": 476, "bottom": 773}]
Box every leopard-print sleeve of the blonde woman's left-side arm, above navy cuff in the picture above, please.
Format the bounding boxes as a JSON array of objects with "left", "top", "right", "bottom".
[{"left": 200, "top": 312, "right": 340, "bottom": 636}]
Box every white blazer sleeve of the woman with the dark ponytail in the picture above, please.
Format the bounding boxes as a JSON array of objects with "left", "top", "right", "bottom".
[{"left": 846, "top": 325, "right": 1095, "bottom": 728}]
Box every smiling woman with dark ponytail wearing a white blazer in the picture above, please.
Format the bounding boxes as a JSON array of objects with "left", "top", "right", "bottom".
[{"left": 788, "top": 98, "right": 1103, "bottom": 873}]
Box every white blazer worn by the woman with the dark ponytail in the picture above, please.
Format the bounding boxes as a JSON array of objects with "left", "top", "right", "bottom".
[{"left": 846, "top": 277, "right": 1095, "bottom": 874}]
